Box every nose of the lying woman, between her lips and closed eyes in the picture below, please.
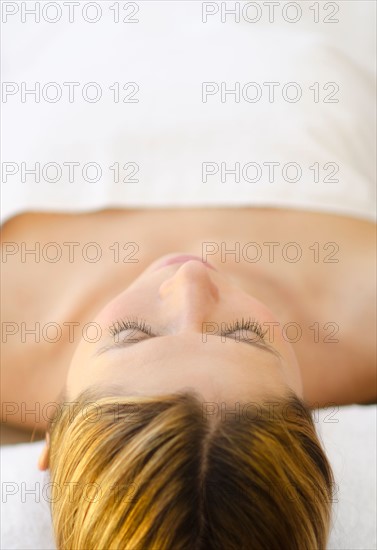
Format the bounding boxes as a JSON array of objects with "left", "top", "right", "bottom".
[{"left": 159, "top": 261, "right": 219, "bottom": 330}]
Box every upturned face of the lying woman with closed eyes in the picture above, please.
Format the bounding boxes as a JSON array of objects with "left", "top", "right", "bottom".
[{"left": 67, "top": 255, "right": 302, "bottom": 410}]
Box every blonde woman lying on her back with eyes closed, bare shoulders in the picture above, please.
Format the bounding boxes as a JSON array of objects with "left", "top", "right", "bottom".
[{"left": 2, "top": 208, "right": 376, "bottom": 549}]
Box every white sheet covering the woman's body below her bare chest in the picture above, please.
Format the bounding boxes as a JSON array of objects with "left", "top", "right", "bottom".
[{"left": 1, "top": 0, "right": 376, "bottom": 222}]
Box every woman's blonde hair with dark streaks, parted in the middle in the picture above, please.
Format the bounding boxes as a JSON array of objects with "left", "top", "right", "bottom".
[{"left": 49, "top": 390, "right": 333, "bottom": 550}]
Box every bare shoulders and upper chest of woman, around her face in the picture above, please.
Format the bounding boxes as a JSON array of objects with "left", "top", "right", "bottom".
[{"left": 1, "top": 208, "right": 377, "bottom": 444}]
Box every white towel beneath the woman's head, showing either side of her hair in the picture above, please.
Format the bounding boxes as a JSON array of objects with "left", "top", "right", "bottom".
[{"left": 1, "top": 405, "right": 377, "bottom": 550}]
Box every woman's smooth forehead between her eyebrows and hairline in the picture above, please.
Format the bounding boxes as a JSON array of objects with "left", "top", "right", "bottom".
[{"left": 75, "top": 334, "right": 286, "bottom": 406}]
